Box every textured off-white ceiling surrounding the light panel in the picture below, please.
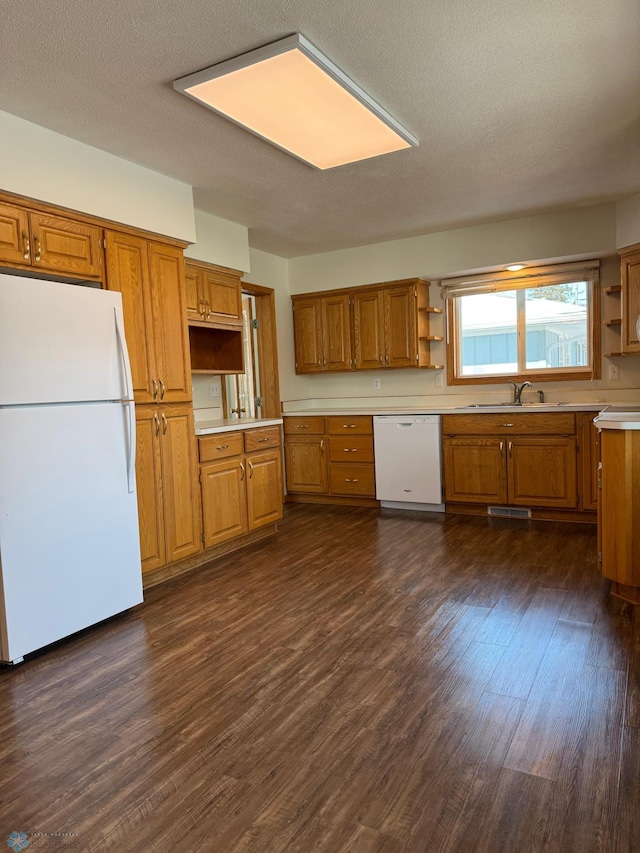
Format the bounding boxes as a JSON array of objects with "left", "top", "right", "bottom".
[{"left": 0, "top": 0, "right": 640, "bottom": 257}]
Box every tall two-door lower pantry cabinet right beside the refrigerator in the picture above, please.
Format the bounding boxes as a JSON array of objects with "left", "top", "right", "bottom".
[{"left": 136, "top": 404, "right": 202, "bottom": 572}]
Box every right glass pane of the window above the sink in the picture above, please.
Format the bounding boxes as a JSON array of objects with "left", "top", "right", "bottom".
[{"left": 525, "top": 281, "right": 589, "bottom": 370}]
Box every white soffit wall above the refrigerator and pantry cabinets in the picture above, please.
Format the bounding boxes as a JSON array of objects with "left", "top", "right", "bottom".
[{"left": 0, "top": 112, "right": 196, "bottom": 243}]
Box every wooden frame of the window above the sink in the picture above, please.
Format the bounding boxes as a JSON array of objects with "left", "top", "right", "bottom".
[{"left": 441, "top": 267, "right": 602, "bottom": 385}]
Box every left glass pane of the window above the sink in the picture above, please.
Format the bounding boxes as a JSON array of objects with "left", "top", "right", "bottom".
[{"left": 457, "top": 290, "right": 518, "bottom": 376}]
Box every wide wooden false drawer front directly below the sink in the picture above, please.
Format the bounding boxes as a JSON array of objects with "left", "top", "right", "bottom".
[{"left": 442, "top": 412, "right": 576, "bottom": 435}]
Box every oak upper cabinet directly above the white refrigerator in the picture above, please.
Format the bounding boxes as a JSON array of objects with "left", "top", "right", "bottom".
[{"left": 0, "top": 203, "right": 103, "bottom": 280}]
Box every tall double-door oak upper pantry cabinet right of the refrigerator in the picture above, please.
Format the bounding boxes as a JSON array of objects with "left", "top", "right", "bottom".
[{"left": 105, "top": 231, "right": 191, "bottom": 403}]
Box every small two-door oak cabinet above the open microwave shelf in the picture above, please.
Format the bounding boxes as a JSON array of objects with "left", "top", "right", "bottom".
[{"left": 185, "top": 261, "right": 242, "bottom": 327}]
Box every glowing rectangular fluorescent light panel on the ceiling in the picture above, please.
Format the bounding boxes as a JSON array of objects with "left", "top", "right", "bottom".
[{"left": 173, "top": 34, "right": 418, "bottom": 169}]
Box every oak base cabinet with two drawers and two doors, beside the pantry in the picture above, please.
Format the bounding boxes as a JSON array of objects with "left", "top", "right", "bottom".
[{"left": 199, "top": 428, "right": 283, "bottom": 548}]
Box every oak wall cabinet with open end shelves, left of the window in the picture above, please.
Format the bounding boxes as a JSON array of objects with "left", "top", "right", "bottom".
[{"left": 292, "top": 279, "right": 442, "bottom": 373}]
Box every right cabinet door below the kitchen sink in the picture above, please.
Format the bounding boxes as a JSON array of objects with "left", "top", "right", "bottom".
[{"left": 507, "top": 436, "right": 578, "bottom": 509}]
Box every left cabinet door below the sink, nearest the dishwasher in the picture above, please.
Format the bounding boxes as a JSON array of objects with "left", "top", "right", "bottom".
[{"left": 444, "top": 437, "right": 507, "bottom": 504}]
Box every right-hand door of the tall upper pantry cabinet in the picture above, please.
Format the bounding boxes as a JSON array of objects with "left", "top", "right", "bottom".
[{"left": 149, "top": 243, "right": 191, "bottom": 403}]
